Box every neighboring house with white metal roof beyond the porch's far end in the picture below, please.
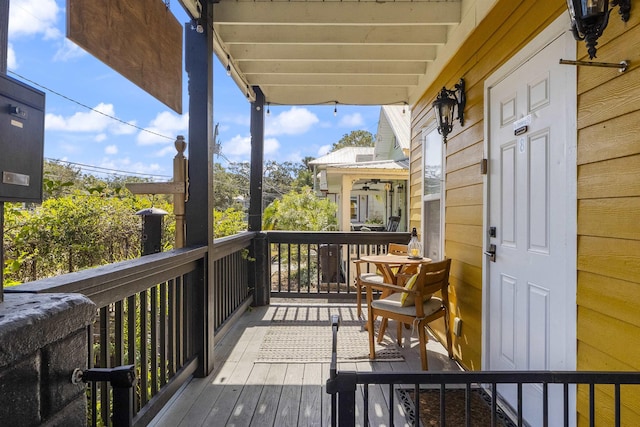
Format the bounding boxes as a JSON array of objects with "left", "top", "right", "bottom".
[{"left": 309, "top": 106, "right": 410, "bottom": 231}]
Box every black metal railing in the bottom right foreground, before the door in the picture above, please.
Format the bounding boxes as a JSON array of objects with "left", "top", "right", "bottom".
[{"left": 326, "top": 316, "right": 640, "bottom": 427}]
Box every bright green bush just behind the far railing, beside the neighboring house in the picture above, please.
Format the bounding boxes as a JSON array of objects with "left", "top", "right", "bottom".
[{"left": 263, "top": 187, "right": 338, "bottom": 231}]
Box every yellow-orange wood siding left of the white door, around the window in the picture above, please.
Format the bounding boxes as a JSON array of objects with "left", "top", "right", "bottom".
[{"left": 410, "top": 0, "right": 566, "bottom": 370}]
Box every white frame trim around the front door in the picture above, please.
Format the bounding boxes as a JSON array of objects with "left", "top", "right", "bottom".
[{"left": 481, "top": 12, "right": 578, "bottom": 370}]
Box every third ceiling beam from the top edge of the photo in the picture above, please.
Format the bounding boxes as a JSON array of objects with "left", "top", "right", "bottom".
[{"left": 229, "top": 44, "right": 436, "bottom": 62}]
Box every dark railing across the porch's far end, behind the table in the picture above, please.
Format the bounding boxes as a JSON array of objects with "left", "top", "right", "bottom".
[{"left": 267, "top": 231, "right": 410, "bottom": 298}]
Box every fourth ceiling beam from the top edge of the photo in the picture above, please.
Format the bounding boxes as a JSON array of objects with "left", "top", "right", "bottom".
[{"left": 242, "top": 61, "right": 426, "bottom": 75}]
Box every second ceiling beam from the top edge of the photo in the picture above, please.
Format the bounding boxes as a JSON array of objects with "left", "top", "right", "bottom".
[{"left": 214, "top": 24, "right": 447, "bottom": 46}]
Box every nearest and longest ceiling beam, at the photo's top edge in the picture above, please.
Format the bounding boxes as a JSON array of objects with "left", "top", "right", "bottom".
[{"left": 213, "top": 1, "right": 462, "bottom": 26}]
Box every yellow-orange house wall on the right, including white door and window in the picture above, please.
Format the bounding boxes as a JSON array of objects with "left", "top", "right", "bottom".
[{"left": 410, "top": 0, "right": 640, "bottom": 425}]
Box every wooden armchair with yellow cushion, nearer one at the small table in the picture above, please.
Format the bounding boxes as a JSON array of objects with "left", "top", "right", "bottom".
[{"left": 365, "top": 259, "right": 453, "bottom": 371}]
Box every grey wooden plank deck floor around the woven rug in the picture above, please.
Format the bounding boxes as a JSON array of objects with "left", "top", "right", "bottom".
[{"left": 150, "top": 300, "right": 459, "bottom": 427}]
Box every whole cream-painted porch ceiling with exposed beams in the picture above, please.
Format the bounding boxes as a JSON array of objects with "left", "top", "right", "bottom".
[{"left": 213, "top": 0, "right": 464, "bottom": 105}]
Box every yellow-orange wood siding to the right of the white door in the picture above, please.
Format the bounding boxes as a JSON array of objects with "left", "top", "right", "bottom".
[{"left": 577, "top": 7, "right": 640, "bottom": 425}]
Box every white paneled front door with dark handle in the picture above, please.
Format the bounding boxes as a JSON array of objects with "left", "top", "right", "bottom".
[{"left": 485, "top": 25, "right": 576, "bottom": 425}]
